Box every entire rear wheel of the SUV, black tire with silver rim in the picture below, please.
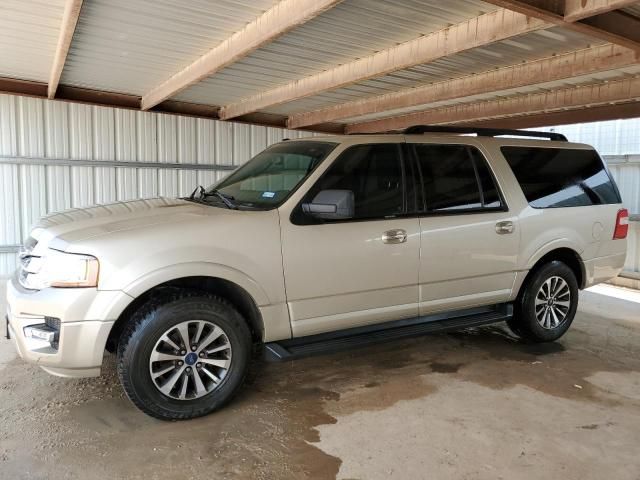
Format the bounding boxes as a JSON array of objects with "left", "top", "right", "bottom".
[{"left": 508, "top": 260, "right": 578, "bottom": 342}]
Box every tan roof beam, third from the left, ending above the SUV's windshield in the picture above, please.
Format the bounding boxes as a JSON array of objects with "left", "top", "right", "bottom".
[{"left": 220, "top": 9, "right": 551, "bottom": 120}]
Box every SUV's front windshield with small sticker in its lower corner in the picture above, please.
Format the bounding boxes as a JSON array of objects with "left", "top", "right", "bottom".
[{"left": 204, "top": 141, "right": 337, "bottom": 208}]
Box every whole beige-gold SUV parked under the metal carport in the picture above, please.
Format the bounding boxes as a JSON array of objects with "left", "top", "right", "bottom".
[{"left": 7, "top": 126, "right": 628, "bottom": 419}]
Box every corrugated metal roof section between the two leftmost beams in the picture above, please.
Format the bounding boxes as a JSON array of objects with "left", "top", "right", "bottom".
[{"left": 61, "top": 0, "right": 275, "bottom": 95}]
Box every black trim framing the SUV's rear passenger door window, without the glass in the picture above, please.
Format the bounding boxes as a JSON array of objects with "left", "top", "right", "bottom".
[{"left": 407, "top": 142, "right": 509, "bottom": 217}]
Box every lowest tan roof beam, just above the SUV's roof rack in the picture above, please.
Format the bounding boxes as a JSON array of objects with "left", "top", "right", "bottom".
[{"left": 346, "top": 77, "right": 640, "bottom": 133}]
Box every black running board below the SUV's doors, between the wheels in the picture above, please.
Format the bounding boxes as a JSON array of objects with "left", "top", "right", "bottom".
[{"left": 264, "top": 303, "right": 513, "bottom": 361}]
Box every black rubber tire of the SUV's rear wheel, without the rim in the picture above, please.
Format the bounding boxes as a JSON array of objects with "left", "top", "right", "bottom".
[{"left": 507, "top": 260, "right": 578, "bottom": 343}]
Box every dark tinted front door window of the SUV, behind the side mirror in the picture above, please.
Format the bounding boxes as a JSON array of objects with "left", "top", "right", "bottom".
[{"left": 307, "top": 143, "right": 404, "bottom": 219}]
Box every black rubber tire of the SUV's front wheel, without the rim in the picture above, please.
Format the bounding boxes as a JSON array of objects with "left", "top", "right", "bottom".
[{"left": 117, "top": 290, "right": 252, "bottom": 420}]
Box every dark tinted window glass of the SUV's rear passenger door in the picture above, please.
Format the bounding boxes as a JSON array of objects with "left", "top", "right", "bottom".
[{"left": 414, "top": 144, "right": 502, "bottom": 212}]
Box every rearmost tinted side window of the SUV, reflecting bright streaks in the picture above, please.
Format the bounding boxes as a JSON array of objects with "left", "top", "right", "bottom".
[{"left": 501, "top": 147, "right": 621, "bottom": 208}]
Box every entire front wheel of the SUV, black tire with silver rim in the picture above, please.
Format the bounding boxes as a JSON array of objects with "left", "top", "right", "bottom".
[{"left": 118, "top": 291, "right": 251, "bottom": 420}]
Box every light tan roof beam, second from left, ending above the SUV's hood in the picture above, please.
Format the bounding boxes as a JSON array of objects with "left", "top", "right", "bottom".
[{"left": 142, "top": 0, "right": 342, "bottom": 110}]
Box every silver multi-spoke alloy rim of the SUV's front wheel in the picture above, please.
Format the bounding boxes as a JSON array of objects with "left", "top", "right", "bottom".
[{"left": 149, "top": 320, "right": 232, "bottom": 400}]
